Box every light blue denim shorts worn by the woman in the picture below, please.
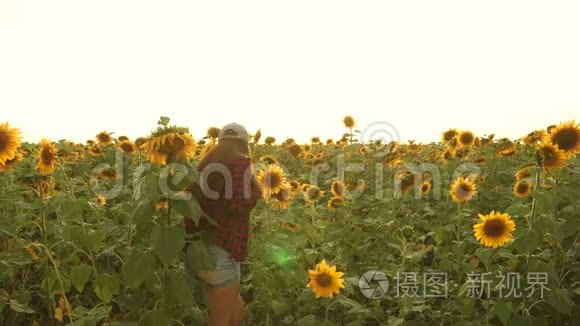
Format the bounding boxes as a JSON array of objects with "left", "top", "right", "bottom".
[{"left": 193, "top": 244, "right": 240, "bottom": 287}]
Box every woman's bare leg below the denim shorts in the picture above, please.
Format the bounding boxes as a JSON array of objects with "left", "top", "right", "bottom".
[{"left": 205, "top": 281, "right": 241, "bottom": 326}]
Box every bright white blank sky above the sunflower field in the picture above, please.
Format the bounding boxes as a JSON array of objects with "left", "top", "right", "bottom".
[{"left": 0, "top": 0, "right": 580, "bottom": 141}]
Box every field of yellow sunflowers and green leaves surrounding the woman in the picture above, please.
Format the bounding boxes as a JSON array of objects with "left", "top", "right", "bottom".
[{"left": 0, "top": 116, "right": 580, "bottom": 326}]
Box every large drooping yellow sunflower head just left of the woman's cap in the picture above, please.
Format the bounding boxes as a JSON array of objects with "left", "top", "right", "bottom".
[{"left": 142, "top": 130, "right": 195, "bottom": 165}]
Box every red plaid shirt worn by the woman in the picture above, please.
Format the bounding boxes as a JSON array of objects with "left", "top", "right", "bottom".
[{"left": 185, "top": 157, "right": 261, "bottom": 261}]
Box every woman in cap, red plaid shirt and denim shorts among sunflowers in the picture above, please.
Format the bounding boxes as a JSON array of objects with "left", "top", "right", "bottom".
[{"left": 186, "top": 123, "right": 261, "bottom": 326}]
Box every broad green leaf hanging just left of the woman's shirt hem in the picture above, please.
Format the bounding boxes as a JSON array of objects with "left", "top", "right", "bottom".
[{"left": 151, "top": 224, "right": 185, "bottom": 265}]
